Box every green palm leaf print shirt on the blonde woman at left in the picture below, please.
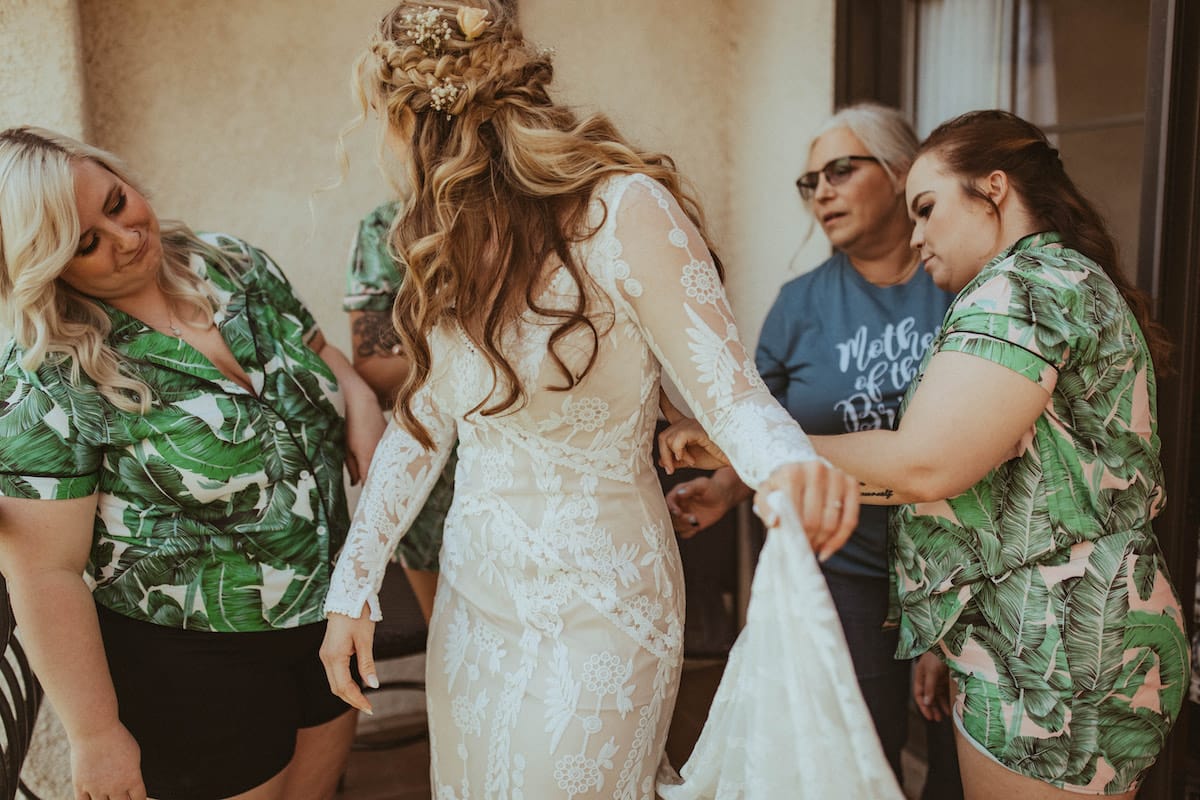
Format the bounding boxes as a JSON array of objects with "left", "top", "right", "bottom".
[{"left": 0, "top": 235, "right": 348, "bottom": 631}]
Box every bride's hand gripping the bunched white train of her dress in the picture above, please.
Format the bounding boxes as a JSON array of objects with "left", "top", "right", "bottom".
[{"left": 755, "top": 459, "right": 858, "bottom": 561}]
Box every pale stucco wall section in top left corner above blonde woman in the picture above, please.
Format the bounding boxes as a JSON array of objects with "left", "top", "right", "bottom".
[{"left": 0, "top": 0, "right": 86, "bottom": 137}]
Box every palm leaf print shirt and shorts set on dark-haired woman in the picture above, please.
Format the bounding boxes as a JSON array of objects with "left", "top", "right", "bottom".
[{"left": 889, "top": 234, "right": 1189, "bottom": 794}]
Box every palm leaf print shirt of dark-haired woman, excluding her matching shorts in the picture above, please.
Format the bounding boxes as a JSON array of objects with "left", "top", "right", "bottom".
[{"left": 890, "top": 233, "right": 1165, "bottom": 658}]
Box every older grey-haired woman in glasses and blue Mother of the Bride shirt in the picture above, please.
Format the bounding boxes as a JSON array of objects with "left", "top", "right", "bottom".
[{"left": 666, "top": 104, "right": 959, "bottom": 798}]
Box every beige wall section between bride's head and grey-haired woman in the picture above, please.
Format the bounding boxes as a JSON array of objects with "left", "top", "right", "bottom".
[{"left": 520, "top": 0, "right": 833, "bottom": 343}]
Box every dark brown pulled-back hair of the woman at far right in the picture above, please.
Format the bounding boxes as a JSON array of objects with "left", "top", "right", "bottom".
[{"left": 917, "top": 109, "right": 1172, "bottom": 374}]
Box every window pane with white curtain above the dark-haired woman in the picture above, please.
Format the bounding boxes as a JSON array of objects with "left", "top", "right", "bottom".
[{"left": 907, "top": 0, "right": 1151, "bottom": 277}]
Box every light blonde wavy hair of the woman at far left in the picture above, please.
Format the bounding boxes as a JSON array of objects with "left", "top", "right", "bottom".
[{"left": 0, "top": 126, "right": 226, "bottom": 414}]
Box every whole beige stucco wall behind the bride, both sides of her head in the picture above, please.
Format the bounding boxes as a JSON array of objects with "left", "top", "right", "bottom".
[{"left": 7, "top": 0, "right": 833, "bottom": 357}]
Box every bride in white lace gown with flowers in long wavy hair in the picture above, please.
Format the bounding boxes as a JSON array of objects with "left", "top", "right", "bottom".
[{"left": 323, "top": 1, "right": 858, "bottom": 798}]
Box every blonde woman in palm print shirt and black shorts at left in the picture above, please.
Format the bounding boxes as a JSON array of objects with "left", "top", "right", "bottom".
[{"left": 0, "top": 127, "right": 383, "bottom": 800}]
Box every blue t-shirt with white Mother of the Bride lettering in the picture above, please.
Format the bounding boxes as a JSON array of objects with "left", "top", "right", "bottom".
[{"left": 755, "top": 252, "right": 954, "bottom": 578}]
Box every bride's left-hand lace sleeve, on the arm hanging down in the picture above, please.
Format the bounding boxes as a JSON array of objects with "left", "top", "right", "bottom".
[{"left": 325, "top": 375, "right": 456, "bottom": 621}]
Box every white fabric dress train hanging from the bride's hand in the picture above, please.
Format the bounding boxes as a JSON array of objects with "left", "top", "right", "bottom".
[{"left": 658, "top": 492, "right": 904, "bottom": 800}]
